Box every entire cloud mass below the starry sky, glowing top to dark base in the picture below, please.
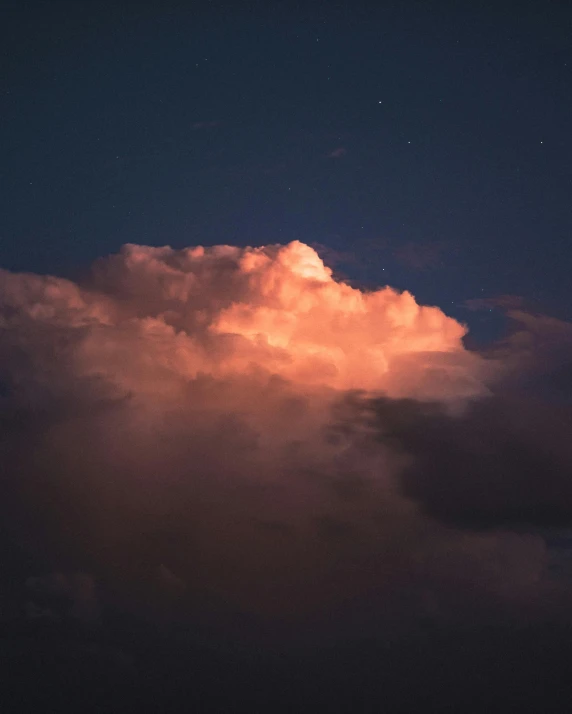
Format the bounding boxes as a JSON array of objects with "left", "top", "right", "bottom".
[{"left": 0, "top": 243, "right": 572, "bottom": 711}]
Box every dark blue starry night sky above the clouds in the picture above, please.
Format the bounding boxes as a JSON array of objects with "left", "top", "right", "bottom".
[{"left": 0, "top": 0, "right": 572, "bottom": 336}]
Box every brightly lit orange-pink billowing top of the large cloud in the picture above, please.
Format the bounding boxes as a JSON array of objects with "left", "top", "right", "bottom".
[{"left": 20, "top": 242, "right": 489, "bottom": 399}]
